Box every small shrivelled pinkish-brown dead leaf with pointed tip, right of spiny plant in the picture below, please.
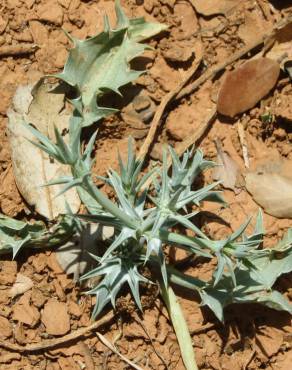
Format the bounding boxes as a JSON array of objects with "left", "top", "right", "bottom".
[{"left": 213, "top": 139, "right": 240, "bottom": 193}]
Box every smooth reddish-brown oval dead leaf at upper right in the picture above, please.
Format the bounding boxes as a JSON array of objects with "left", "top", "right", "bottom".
[{"left": 217, "top": 58, "right": 280, "bottom": 117}]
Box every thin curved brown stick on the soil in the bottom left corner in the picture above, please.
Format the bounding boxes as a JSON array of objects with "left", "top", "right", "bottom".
[{"left": 0, "top": 312, "right": 115, "bottom": 352}]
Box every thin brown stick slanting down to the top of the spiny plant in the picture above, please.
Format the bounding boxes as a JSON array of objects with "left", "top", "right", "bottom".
[{"left": 138, "top": 51, "right": 202, "bottom": 159}]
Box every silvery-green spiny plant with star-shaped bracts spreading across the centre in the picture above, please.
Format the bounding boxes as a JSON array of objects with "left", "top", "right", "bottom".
[{"left": 28, "top": 126, "right": 292, "bottom": 320}]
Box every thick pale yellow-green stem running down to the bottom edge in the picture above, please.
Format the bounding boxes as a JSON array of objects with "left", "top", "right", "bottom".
[{"left": 160, "top": 281, "right": 198, "bottom": 370}]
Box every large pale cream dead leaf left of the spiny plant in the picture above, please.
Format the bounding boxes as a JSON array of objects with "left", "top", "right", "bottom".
[{"left": 7, "top": 84, "right": 80, "bottom": 219}]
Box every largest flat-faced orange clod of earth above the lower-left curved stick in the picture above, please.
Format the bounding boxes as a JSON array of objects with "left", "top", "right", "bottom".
[{"left": 41, "top": 298, "right": 70, "bottom": 335}]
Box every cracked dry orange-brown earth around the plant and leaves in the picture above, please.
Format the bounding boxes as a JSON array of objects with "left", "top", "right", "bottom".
[{"left": 0, "top": 0, "right": 292, "bottom": 370}]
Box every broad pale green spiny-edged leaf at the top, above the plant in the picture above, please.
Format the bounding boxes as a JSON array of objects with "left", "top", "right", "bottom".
[{"left": 54, "top": 1, "right": 166, "bottom": 127}]
